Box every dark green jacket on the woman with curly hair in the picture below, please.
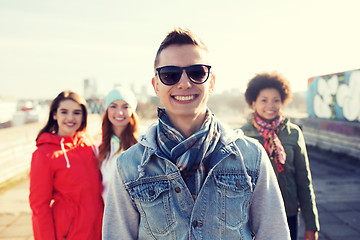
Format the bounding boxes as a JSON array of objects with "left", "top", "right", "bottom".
[{"left": 241, "top": 118, "right": 320, "bottom": 231}]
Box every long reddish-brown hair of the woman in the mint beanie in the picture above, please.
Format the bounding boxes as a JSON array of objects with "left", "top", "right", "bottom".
[{"left": 99, "top": 109, "right": 139, "bottom": 166}]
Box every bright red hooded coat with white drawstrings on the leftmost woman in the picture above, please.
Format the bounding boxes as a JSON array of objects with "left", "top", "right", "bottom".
[{"left": 29, "top": 133, "right": 104, "bottom": 240}]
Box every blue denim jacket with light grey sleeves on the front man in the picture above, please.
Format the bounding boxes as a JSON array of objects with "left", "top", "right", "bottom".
[{"left": 103, "top": 125, "right": 290, "bottom": 240}]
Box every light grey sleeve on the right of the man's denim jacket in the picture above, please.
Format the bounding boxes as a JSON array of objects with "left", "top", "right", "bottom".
[{"left": 250, "top": 147, "right": 290, "bottom": 240}]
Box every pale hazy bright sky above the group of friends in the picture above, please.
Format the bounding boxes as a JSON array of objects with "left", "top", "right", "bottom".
[{"left": 0, "top": 0, "right": 360, "bottom": 99}]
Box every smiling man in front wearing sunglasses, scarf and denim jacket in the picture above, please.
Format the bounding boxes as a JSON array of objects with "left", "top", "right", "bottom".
[{"left": 103, "top": 29, "right": 290, "bottom": 240}]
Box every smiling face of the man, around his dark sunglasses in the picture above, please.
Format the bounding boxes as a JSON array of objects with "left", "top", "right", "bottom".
[{"left": 152, "top": 44, "right": 215, "bottom": 122}]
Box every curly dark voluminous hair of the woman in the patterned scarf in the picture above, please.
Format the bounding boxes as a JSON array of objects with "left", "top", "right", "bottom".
[{"left": 245, "top": 72, "right": 292, "bottom": 107}]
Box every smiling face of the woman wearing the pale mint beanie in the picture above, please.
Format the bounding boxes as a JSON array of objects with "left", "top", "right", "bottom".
[{"left": 107, "top": 100, "right": 133, "bottom": 137}]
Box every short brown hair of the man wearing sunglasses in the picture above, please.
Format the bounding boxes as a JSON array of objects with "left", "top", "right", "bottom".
[{"left": 154, "top": 28, "right": 208, "bottom": 68}]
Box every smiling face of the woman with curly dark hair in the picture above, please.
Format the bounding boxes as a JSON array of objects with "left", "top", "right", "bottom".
[{"left": 252, "top": 88, "right": 282, "bottom": 122}]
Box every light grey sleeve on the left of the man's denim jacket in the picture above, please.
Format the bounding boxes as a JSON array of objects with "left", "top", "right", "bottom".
[{"left": 102, "top": 161, "right": 139, "bottom": 240}]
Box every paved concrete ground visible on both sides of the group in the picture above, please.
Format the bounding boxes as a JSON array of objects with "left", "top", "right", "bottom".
[{"left": 0, "top": 149, "right": 360, "bottom": 240}]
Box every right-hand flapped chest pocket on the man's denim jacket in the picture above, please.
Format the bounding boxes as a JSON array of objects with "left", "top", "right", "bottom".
[{"left": 214, "top": 173, "right": 251, "bottom": 229}]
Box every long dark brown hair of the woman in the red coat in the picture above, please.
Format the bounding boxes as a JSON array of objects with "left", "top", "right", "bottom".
[{"left": 36, "top": 91, "right": 87, "bottom": 140}]
